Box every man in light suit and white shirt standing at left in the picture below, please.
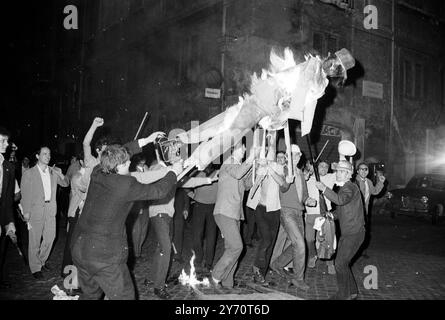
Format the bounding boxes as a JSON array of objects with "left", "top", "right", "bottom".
[{"left": 20, "top": 147, "right": 69, "bottom": 279}]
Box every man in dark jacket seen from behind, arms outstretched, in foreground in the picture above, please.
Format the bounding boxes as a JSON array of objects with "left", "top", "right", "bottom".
[{"left": 71, "top": 139, "right": 182, "bottom": 300}]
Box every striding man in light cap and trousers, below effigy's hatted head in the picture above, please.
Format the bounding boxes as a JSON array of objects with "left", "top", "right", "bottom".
[{"left": 271, "top": 144, "right": 317, "bottom": 290}]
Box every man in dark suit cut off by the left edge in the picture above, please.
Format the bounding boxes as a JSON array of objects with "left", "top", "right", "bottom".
[{"left": 0, "top": 127, "right": 15, "bottom": 288}]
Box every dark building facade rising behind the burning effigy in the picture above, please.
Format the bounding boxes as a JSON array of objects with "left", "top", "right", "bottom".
[{"left": 60, "top": 0, "right": 445, "bottom": 184}]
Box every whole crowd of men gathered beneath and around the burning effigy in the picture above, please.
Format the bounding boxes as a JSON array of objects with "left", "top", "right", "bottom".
[{"left": 0, "top": 118, "right": 385, "bottom": 299}]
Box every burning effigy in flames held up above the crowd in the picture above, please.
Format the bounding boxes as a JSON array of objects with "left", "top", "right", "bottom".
[{"left": 177, "top": 48, "right": 355, "bottom": 170}]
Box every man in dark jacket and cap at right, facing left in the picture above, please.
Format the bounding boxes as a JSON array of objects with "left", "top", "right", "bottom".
[{"left": 315, "top": 160, "right": 365, "bottom": 300}]
